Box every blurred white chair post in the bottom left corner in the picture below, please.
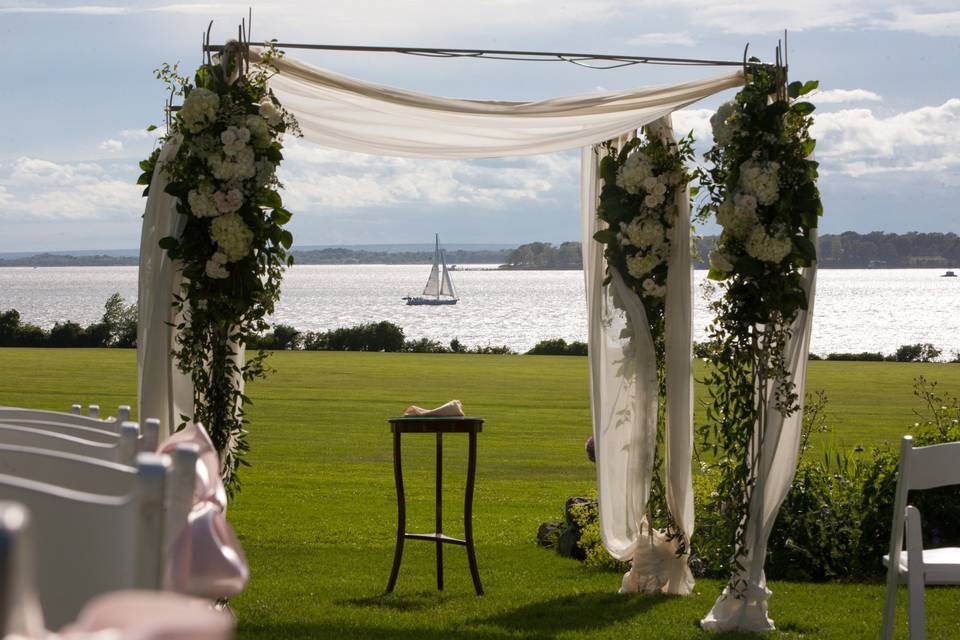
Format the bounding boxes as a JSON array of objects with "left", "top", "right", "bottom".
[{"left": 0, "top": 502, "right": 46, "bottom": 638}]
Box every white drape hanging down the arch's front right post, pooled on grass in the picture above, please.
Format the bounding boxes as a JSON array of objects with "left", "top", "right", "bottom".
[{"left": 700, "top": 229, "right": 817, "bottom": 632}]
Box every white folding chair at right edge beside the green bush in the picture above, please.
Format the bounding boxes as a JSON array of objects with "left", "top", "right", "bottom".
[{"left": 881, "top": 436, "right": 960, "bottom": 640}]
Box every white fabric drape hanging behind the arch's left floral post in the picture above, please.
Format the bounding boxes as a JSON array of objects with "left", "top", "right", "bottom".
[{"left": 137, "top": 138, "right": 193, "bottom": 438}]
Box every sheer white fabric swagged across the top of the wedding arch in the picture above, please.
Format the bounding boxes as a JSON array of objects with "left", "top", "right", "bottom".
[{"left": 251, "top": 51, "right": 743, "bottom": 159}]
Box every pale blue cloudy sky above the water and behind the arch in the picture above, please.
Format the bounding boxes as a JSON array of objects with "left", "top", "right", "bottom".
[{"left": 0, "top": 0, "right": 960, "bottom": 252}]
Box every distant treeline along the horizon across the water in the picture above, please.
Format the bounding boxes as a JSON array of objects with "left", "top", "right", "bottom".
[{"left": 0, "top": 231, "right": 960, "bottom": 269}]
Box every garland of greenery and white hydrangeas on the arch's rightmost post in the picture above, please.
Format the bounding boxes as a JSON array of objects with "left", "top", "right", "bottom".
[{"left": 699, "top": 64, "right": 823, "bottom": 596}]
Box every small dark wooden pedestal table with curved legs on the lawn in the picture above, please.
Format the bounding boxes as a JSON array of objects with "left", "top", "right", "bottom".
[{"left": 387, "top": 416, "right": 483, "bottom": 596}]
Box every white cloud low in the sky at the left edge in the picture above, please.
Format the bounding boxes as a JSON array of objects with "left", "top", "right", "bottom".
[{"left": 0, "top": 157, "right": 143, "bottom": 220}]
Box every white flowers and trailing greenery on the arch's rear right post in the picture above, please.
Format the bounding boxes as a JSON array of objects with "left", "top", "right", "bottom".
[{"left": 593, "top": 130, "right": 693, "bottom": 555}]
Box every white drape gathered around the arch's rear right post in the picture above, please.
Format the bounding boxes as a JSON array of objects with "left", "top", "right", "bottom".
[{"left": 581, "top": 116, "right": 694, "bottom": 594}]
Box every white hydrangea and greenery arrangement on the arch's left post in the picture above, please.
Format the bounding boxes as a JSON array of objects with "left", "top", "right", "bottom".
[{"left": 139, "top": 45, "right": 298, "bottom": 492}]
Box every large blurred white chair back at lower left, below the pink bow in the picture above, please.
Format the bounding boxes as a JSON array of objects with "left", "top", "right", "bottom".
[{"left": 0, "top": 453, "right": 169, "bottom": 629}]
